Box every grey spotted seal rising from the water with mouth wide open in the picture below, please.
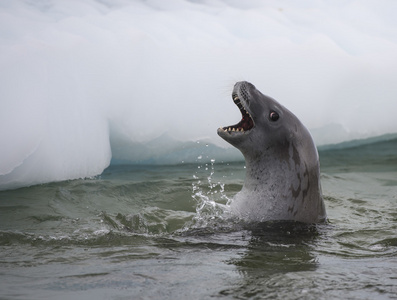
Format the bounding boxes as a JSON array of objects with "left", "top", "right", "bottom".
[{"left": 218, "top": 81, "right": 326, "bottom": 223}]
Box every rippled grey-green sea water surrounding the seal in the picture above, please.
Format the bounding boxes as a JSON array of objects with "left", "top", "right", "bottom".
[{"left": 0, "top": 135, "right": 397, "bottom": 299}]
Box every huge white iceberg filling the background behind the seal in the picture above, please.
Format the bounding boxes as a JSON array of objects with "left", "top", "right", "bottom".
[{"left": 0, "top": 0, "right": 397, "bottom": 189}]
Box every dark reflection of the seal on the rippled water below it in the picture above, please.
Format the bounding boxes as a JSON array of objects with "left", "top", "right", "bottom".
[{"left": 218, "top": 222, "right": 327, "bottom": 299}]
